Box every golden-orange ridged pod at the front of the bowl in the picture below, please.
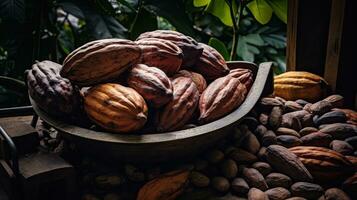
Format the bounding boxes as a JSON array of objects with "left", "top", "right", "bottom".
[{"left": 84, "top": 83, "right": 148, "bottom": 133}]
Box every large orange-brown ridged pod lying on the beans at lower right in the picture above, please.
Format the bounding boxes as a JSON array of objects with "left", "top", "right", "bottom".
[{"left": 289, "top": 146, "right": 353, "bottom": 182}]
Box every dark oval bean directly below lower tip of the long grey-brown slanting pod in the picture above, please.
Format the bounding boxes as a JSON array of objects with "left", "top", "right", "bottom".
[{"left": 290, "top": 182, "right": 324, "bottom": 199}]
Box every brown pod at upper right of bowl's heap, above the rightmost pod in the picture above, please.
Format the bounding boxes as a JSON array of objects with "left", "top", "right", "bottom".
[{"left": 193, "top": 43, "right": 229, "bottom": 81}]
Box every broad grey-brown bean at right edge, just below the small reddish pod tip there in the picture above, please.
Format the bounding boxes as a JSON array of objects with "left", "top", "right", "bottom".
[{"left": 320, "top": 123, "right": 357, "bottom": 140}]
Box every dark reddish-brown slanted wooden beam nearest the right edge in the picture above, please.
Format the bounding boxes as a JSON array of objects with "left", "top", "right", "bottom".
[{"left": 324, "top": 0, "right": 345, "bottom": 91}]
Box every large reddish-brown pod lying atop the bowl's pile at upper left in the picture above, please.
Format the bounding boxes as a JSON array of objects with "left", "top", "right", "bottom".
[{"left": 61, "top": 39, "right": 141, "bottom": 86}]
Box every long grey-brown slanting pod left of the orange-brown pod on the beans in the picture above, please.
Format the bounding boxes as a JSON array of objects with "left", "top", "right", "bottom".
[{"left": 266, "top": 145, "right": 312, "bottom": 181}]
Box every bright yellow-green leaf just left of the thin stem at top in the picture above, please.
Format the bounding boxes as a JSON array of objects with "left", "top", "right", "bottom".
[{"left": 206, "top": 0, "right": 237, "bottom": 26}]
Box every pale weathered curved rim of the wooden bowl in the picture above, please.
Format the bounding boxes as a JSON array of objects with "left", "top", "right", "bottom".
[{"left": 29, "top": 61, "right": 272, "bottom": 145}]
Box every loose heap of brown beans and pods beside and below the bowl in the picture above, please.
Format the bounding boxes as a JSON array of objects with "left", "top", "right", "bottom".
[{"left": 76, "top": 95, "right": 357, "bottom": 200}]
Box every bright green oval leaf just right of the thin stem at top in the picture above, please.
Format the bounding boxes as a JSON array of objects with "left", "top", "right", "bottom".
[{"left": 247, "top": 0, "right": 273, "bottom": 24}]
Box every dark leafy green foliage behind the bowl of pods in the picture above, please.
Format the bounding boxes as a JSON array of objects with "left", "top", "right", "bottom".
[{"left": 0, "top": 0, "right": 287, "bottom": 107}]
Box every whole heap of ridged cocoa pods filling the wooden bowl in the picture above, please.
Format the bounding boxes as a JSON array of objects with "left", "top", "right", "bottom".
[{"left": 26, "top": 30, "right": 253, "bottom": 133}]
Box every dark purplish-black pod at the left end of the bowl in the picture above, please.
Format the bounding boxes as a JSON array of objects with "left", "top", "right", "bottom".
[{"left": 26, "top": 60, "right": 79, "bottom": 116}]
